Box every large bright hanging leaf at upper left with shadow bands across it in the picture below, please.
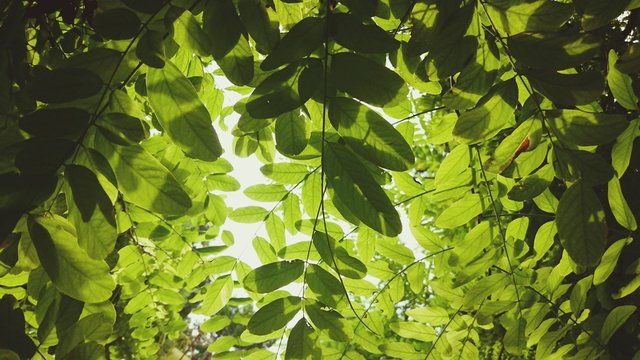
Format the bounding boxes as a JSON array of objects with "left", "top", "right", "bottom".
[{"left": 147, "top": 62, "right": 222, "bottom": 161}]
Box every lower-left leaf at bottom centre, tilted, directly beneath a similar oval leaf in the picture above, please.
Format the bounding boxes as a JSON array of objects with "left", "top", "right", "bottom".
[{"left": 247, "top": 296, "right": 302, "bottom": 335}]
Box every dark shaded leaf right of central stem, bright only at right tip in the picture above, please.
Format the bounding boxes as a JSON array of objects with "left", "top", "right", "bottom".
[{"left": 329, "top": 53, "right": 408, "bottom": 107}]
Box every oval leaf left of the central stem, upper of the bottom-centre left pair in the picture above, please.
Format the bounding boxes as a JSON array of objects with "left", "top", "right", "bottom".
[{"left": 242, "top": 260, "right": 304, "bottom": 294}]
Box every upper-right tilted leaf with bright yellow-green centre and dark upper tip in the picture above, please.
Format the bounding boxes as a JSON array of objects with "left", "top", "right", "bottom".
[{"left": 453, "top": 80, "right": 517, "bottom": 145}]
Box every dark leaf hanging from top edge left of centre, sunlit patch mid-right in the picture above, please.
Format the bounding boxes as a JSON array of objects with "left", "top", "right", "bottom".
[{"left": 202, "top": 0, "right": 254, "bottom": 85}]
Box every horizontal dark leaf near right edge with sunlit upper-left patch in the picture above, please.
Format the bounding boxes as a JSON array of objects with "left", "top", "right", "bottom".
[{"left": 545, "top": 110, "right": 629, "bottom": 146}]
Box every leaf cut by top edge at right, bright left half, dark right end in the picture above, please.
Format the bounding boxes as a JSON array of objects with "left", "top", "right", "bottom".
[{"left": 487, "top": 0, "right": 574, "bottom": 35}]
